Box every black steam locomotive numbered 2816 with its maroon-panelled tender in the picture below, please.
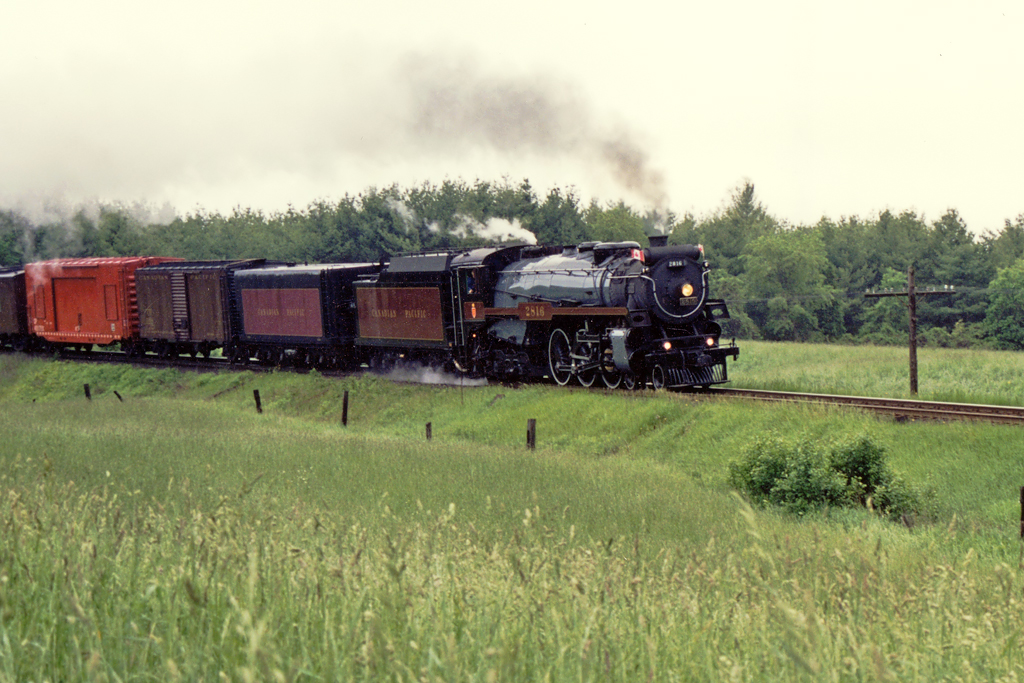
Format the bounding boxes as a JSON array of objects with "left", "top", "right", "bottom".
[{"left": 355, "top": 235, "right": 739, "bottom": 388}]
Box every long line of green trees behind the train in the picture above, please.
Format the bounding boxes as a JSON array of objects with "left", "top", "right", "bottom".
[{"left": 0, "top": 179, "right": 1024, "bottom": 348}]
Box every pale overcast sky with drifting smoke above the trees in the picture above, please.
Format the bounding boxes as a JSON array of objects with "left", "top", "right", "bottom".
[{"left": 0, "top": 0, "right": 1024, "bottom": 232}]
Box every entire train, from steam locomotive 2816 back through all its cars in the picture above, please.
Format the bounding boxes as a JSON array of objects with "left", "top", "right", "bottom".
[{"left": 0, "top": 241, "right": 739, "bottom": 388}]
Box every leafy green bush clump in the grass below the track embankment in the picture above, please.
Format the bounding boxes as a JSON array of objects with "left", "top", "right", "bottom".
[{"left": 729, "top": 433, "right": 921, "bottom": 517}]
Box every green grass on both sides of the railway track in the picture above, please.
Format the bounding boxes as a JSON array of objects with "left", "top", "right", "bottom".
[{"left": 0, "top": 344, "right": 1024, "bottom": 682}]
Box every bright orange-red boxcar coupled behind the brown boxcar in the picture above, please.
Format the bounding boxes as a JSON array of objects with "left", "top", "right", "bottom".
[{"left": 25, "top": 256, "right": 181, "bottom": 345}]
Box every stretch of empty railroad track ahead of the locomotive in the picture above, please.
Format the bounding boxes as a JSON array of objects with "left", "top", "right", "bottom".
[{"left": 705, "top": 388, "right": 1024, "bottom": 425}]
